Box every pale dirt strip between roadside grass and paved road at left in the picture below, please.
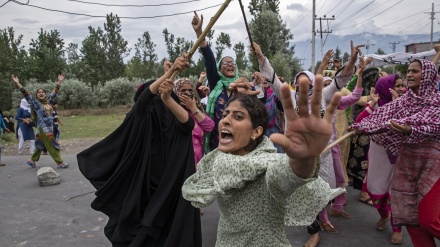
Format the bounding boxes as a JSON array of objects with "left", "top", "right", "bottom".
[{"left": 2, "top": 138, "right": 101, "bottom": 156}]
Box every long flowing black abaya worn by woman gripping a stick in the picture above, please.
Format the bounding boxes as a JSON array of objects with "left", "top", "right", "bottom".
[{"left": 77, "top": 85, "right": 202, "bottom": 247}]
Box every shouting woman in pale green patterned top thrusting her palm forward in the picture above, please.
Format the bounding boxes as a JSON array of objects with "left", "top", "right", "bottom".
[{"left": 182, "top": 76, "right": 344, "bottom": 247}]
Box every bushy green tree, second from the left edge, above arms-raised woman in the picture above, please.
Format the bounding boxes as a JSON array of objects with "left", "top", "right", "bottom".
[{"left": 29, "top": 29, "right": 66, "bottom": 82}]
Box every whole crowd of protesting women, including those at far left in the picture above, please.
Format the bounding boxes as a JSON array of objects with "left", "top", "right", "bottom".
[{"left": 8, "top": 13, "right": 432, "bottom": 247}]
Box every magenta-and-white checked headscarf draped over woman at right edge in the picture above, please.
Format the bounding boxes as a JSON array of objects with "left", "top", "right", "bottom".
[{"left": 352, "top": 59, "right": 440, "bottom": 155}]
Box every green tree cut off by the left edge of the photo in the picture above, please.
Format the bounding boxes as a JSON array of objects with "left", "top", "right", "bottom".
[{"left": 0, "top": 27, "right": 29, "bottom": 110}]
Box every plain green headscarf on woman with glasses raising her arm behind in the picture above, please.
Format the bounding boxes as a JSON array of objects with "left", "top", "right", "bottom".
[{"left": 204, "top": 57, "right": 238, "bottom": 154}]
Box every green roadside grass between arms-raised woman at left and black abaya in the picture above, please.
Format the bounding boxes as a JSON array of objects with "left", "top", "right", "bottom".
[{"left": 0, "top": 106, "right": 131, "bottom": 143}]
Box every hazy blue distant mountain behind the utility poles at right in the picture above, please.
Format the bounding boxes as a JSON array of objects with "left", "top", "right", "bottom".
[{"left": 291, "top": 32, "right": 440, "bottom": 69}]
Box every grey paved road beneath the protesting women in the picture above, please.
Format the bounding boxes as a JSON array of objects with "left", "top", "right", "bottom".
[{"left": 0, "top": 155, "right": 430, "bottom": 247}]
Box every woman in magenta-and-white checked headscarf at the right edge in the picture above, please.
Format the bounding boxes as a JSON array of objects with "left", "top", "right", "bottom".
[{"left": 351, "top": 59, "right": 440, "bottom": 247}]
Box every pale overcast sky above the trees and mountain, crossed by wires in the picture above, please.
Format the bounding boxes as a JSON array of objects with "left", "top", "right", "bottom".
[{"left": 0, "top": 0, "right": 440, "bottom": 67}]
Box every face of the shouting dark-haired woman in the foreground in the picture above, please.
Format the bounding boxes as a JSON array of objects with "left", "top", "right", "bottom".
[{"left": 218, "top": 100, "right": 262, "bottom": 155}]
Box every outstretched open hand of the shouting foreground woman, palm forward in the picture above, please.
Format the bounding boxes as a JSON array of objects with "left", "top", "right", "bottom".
[{"left": 270, "top": 75, "right": 341, "bottom": 178}]
